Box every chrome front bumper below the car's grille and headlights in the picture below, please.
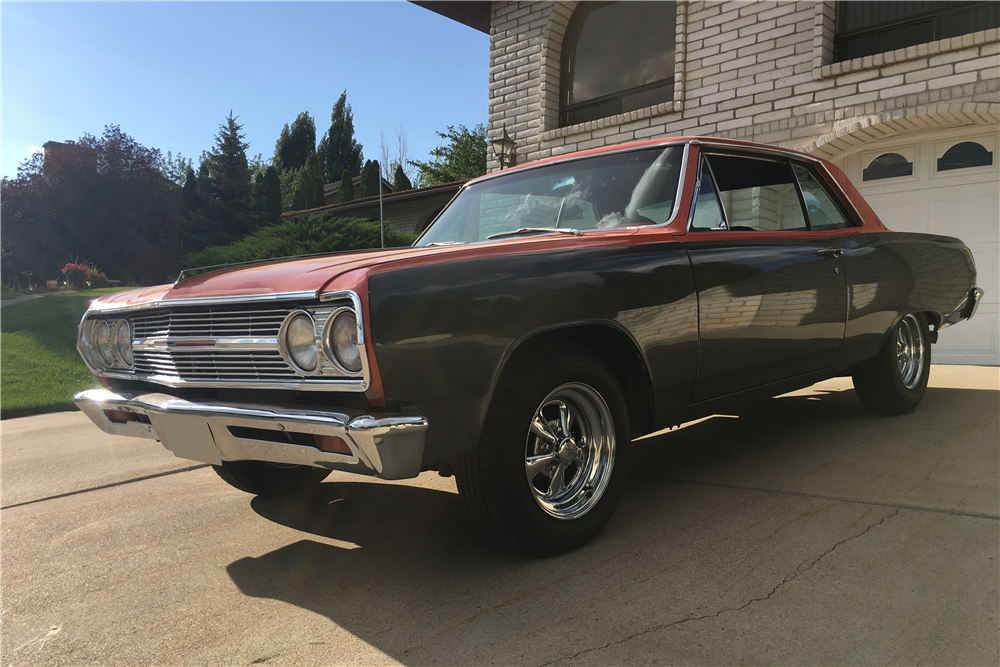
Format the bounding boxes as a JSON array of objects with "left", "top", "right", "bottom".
[{"left": 75, "top": 389, "right": 427, "bottom": 479}]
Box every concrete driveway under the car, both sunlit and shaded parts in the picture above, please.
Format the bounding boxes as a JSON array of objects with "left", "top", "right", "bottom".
[{"left": 0, "top": 367, "right": 1000, "bottom": 667}]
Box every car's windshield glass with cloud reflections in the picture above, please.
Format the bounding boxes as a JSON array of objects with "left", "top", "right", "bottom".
[{"left": 416, "top": 146, "right": 684, "bottom": 246}]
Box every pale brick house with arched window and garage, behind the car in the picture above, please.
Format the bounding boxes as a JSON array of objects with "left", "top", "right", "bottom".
[{"left": 416, "top": 0, "right": 1000, "bottom": 365}]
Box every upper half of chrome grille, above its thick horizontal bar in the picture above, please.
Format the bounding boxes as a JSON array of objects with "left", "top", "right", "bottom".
[{"left": 129, "top": 308, "right": 291, "bottom": 340}]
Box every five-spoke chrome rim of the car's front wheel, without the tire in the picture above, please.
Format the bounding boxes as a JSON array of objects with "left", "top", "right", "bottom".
[{"left": 524, "top": 382, "right": 615, "bottom": 520}]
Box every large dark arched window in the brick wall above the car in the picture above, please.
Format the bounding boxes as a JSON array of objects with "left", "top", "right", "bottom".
[{"left": 559, "top": 2, "right": 677, "bottom": 126}]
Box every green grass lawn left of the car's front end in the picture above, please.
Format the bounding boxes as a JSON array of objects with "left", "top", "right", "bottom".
[{"left": 0, "top": 288, "right": 131, "bottom": 419}]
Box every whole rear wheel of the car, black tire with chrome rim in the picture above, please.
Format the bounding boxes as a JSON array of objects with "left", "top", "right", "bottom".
[{"left": 853, "top": 313, "right": 931, "bottom": 415}]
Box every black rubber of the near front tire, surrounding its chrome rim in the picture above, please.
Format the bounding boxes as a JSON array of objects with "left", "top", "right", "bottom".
[{"left": 483, "top": 350, "right": 630, "bottom": 555}]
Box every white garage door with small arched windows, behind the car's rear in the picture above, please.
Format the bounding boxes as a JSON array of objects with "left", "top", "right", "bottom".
[{"left": 838, "top": 127, "right": 1000, "bottom": 366}]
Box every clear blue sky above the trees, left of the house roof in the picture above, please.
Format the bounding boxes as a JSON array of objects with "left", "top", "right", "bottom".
[{"left": 0, "top": 1, "right": 489, "bottom": 176}]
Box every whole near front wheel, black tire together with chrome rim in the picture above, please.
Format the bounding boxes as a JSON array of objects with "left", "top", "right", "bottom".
[{"left": 455, "top": 345, "right": 630, "bottom": 555}]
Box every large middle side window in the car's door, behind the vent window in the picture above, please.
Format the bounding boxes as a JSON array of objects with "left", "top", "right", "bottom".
[{"left": 707, "top": 155, "right": 808, "bottom": 231}]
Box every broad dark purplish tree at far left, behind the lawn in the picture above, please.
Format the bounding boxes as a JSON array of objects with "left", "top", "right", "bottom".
[{"left": 0, "top": 125, "right": 181, "bottom": 285}]
